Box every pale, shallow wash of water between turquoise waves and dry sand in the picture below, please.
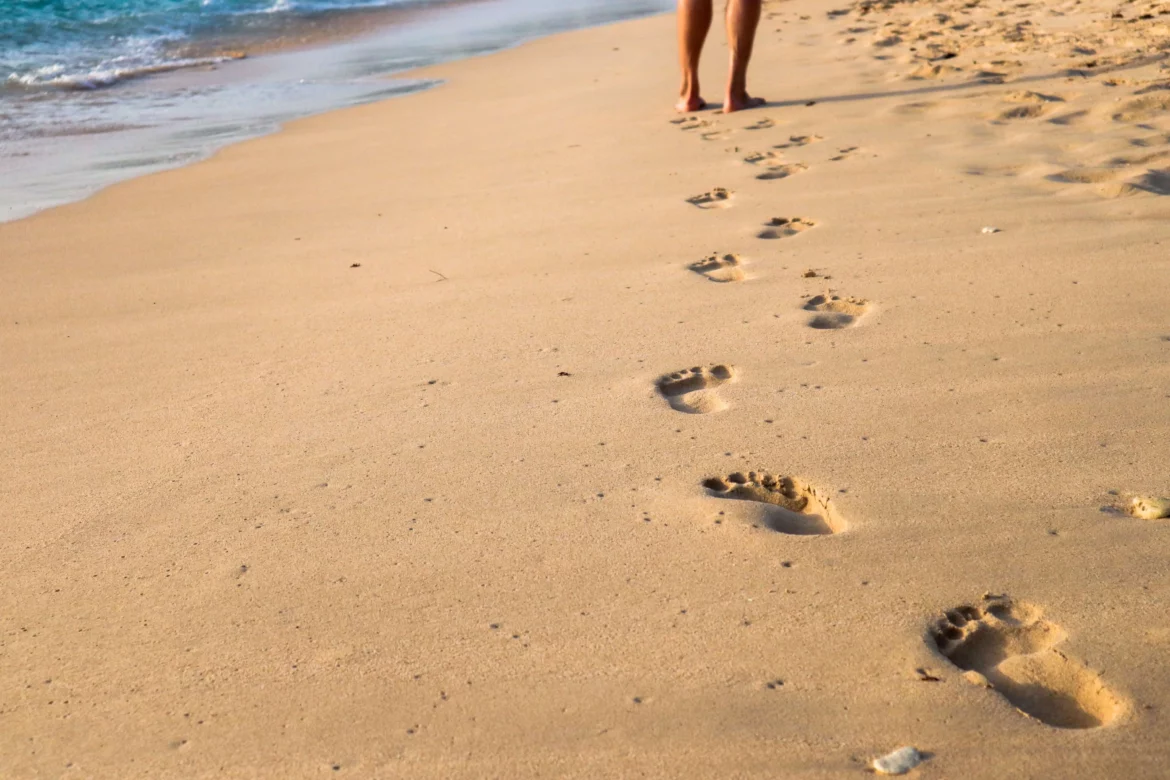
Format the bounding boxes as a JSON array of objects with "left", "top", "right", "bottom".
[{"left": 0, "top": 0, "right": 673, "bottom": 223}]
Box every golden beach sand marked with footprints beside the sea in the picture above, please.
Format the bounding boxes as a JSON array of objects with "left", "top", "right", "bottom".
[{"left": 0, "top": 0, "right": 1170, "bottom": 779}]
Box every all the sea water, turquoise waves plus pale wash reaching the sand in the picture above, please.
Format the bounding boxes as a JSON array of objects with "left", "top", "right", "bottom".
[{"left": 0, "top": 0, "right": 674, "bottom": 221}]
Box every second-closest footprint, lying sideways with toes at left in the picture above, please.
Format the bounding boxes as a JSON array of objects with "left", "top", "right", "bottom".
[{"left": 703, "top": 471, "right": 847, "bottom": 536}]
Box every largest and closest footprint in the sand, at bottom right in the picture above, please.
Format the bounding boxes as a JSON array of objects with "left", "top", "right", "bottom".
[{"left": 930, "top": 595, "right": 1124, "bottom": 729}]
